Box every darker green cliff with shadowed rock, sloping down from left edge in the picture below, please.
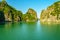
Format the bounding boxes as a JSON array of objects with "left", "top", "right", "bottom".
[{"left": 0, "top": 1, "right": 22, "bottom": 22}]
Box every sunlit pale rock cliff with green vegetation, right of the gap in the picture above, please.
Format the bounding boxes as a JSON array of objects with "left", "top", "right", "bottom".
[{"left": 40, "top": 1, "right": 60, "bottom": 23}]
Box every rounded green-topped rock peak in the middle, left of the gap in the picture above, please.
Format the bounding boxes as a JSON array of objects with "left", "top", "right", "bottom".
[{"left": 23, "top": 8, "right": 37, "bottom": 22}]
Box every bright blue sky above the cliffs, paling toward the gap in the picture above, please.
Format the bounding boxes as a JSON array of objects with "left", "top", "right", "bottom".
[{"left": 0, "top": 0, "right": 58, "bottom": 18}]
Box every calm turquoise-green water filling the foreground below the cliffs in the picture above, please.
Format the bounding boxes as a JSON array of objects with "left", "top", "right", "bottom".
[{"left": 0, "top": 22, "right": 60, "bottom": 40}]
